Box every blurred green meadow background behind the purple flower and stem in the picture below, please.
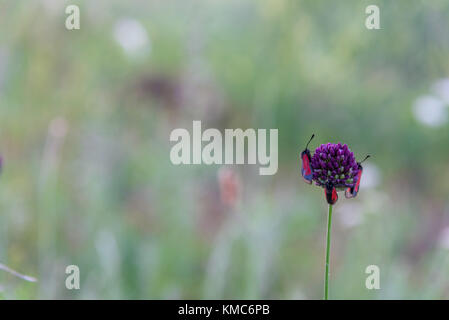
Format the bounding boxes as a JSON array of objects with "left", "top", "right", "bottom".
[{"left": 0, "top": 0, "right": 449, "bottom": 299}]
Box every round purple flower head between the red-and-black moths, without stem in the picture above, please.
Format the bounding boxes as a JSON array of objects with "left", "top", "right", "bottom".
[{"left": 311, "top": 143, "right": 359, "bottom": 190}]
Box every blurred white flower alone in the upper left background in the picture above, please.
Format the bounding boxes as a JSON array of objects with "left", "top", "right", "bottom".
[{"left": 114, "top": 19, "right": 151, "bottom": 56}]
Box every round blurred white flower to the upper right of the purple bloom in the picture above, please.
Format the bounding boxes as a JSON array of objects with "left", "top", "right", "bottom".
[{"left": 412, "top": 96, "right": 448, "bottom": 127}]
